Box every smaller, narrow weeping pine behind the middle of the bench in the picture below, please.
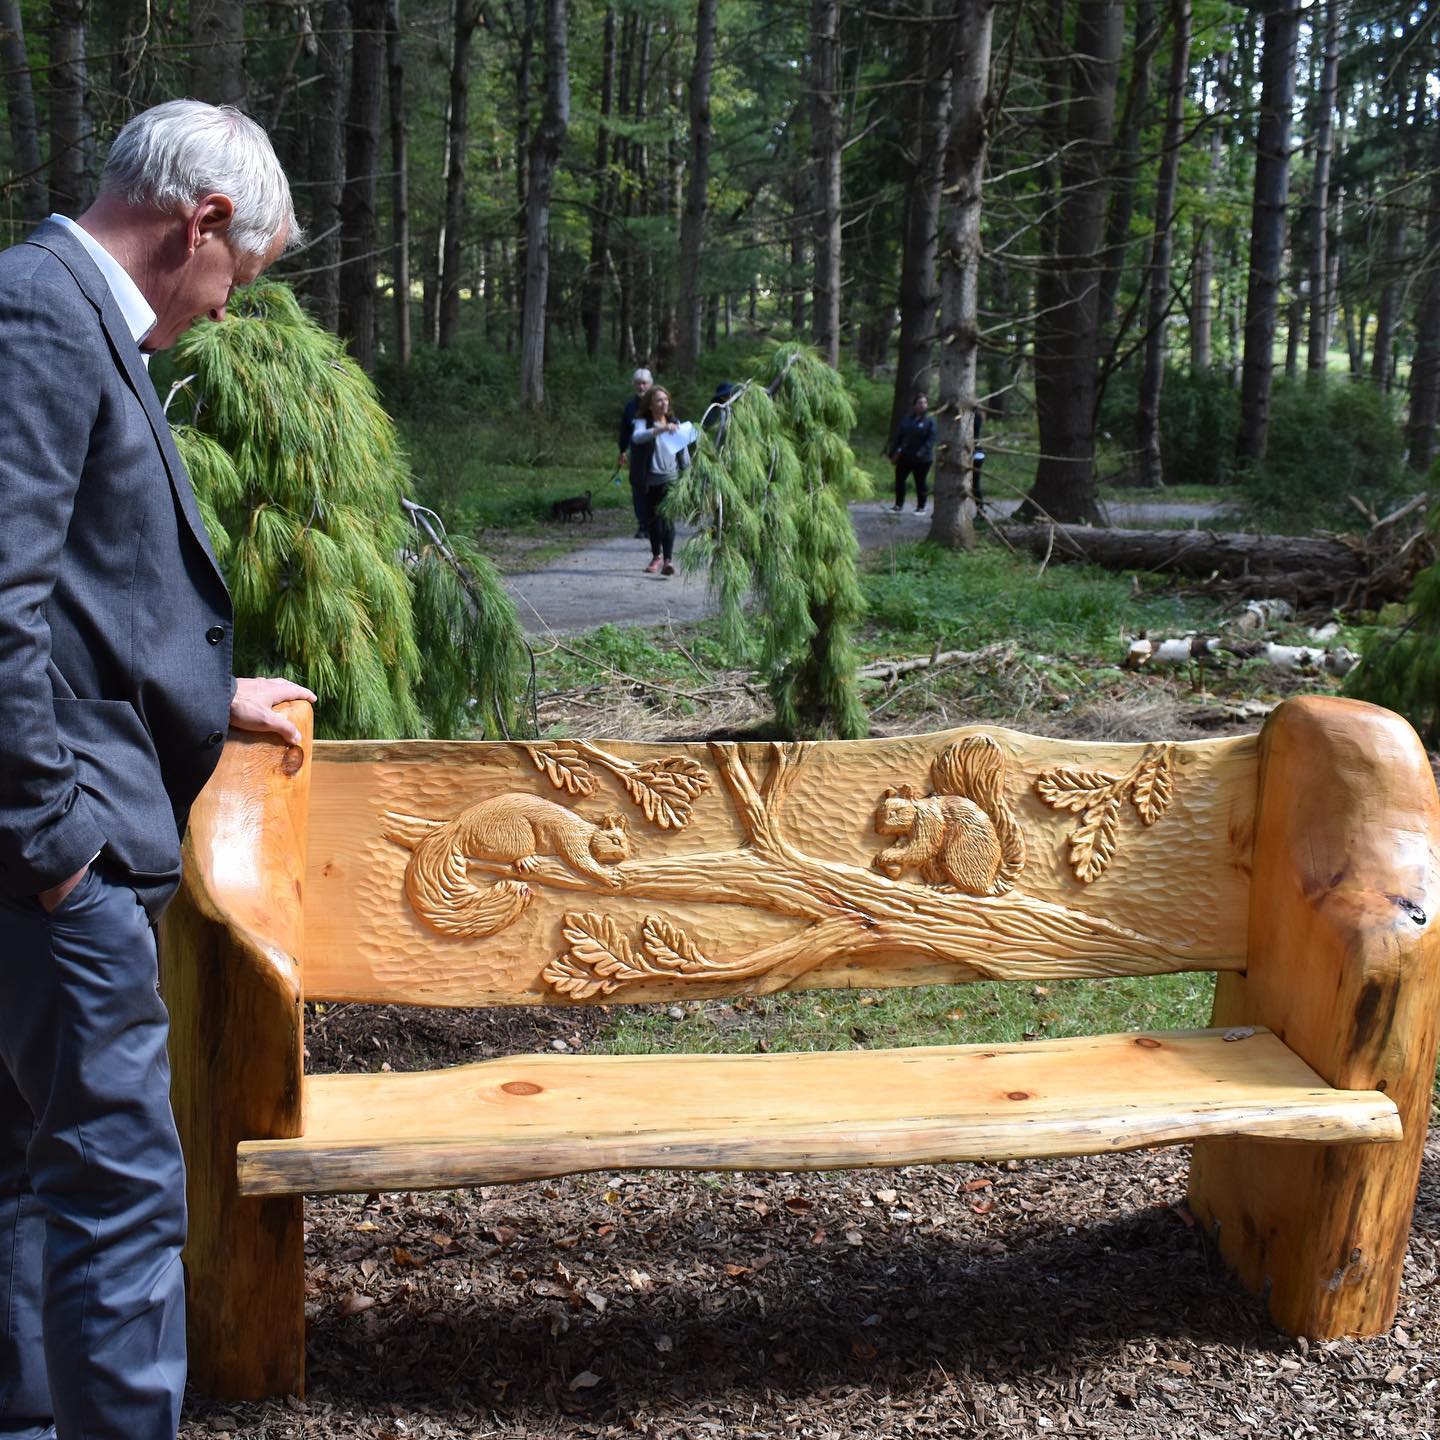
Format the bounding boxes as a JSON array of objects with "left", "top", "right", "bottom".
[{"left": 671, "top": 346, "right": 867, "bottom": 740}]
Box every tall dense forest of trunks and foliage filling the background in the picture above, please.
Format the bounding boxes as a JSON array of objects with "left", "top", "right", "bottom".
[{"left": 0, "top": 0, "right": 1440, "bottom": 544}]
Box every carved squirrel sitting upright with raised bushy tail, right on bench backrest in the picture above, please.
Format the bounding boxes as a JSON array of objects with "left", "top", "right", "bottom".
[{"left": 874, "top": 734, "right": 1025, "bottom": 896}]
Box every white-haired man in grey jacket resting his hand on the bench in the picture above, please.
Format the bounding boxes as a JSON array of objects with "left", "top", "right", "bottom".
[{"left": 0, "top": 101, "right": 314, "bottom": 1440}]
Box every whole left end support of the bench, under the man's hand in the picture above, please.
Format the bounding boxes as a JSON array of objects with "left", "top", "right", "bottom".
[{"left": 160, "top": 704, "right": 311, "bottom": 1400}]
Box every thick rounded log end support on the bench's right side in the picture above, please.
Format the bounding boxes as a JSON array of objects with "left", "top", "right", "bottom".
[{"left": 1189, "top": 697, "right": 1440, "bottom": 1339}]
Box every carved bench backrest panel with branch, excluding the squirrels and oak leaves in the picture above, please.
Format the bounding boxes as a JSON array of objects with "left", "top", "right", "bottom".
[{"left": 305, "top": 727, "right": 1256, "bottom": 1005}]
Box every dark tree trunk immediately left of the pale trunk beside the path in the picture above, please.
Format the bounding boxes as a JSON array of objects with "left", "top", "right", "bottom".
[{"left": 888, "top": 0, "right": 953, "bottom": 435}]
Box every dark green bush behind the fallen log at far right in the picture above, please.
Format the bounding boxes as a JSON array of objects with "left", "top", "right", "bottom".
[{"left": 1244, "top": 379, "right": 1413, "bottom": 530}]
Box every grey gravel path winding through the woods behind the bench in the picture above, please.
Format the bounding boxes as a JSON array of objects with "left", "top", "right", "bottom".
[{"left": 505, "top": 500, "right": 1223, "bottom": 634}]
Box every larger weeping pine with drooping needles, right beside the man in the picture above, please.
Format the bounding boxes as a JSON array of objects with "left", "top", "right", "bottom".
[{"left": 170, "top": 284, "right": 527, "bottom": 739}]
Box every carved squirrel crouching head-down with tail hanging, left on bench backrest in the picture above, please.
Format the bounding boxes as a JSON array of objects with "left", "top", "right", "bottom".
[{"left": 384, "top": 792, "right": 631, "bottom": 936}]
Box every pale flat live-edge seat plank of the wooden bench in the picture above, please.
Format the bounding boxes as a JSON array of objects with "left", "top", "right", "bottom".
[{"left": 239, "top": 1030, "right": 1401, "bottom": 1195}]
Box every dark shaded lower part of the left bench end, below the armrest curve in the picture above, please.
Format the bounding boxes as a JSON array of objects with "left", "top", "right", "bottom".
[{"left": 160, "top": 890, "right": 305, "bottom": 1400}]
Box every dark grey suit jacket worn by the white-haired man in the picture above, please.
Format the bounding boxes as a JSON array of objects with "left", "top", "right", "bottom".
[{"left": 0, "top": 223, "right": 235, "bottom": 914}]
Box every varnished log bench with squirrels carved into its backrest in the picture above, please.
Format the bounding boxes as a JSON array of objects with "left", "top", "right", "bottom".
[{"left": 161, "top": 698, "right": 1440, "bottom": 1398}]
